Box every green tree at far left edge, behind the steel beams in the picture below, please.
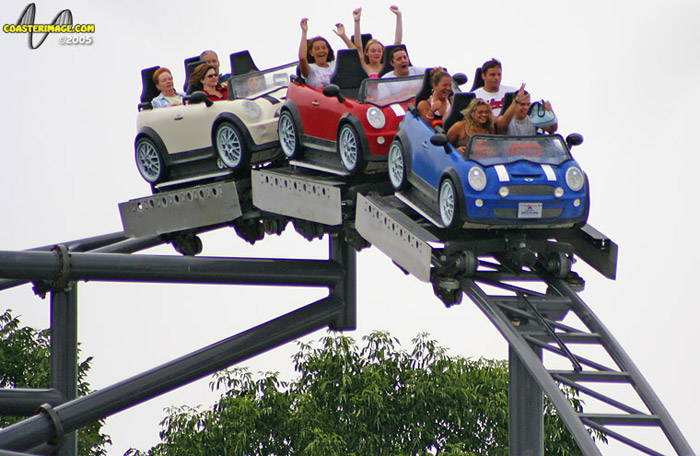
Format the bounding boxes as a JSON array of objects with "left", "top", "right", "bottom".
[{"left": 0, "top": 309, "right": 112, "bottom": 456}]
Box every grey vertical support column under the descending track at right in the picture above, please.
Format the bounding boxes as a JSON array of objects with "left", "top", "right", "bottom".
[{"left": 508, "top": 345, "right": 544, "bottom": 456}]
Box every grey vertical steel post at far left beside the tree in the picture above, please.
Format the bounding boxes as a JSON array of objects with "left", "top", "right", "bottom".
[{"left": 50, "top": 282, "right": 78, "bottom": 456}]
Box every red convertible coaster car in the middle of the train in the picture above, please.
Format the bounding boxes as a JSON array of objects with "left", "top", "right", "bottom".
[{"left": 278, "top": 50, "right": 423, "bottom": 174}]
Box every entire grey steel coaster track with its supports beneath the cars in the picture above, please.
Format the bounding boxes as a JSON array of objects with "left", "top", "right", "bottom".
[{"left": 0, "top": 167, "right": 695, "bottom": 456}]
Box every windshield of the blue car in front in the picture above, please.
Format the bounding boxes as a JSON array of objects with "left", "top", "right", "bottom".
[{"left": 464, "top": 135, "right": 571, "bottom": 166}]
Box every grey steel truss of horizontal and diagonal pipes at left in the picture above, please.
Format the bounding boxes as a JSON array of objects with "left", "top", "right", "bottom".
[{"left": 0, "top": 235, "right": 357, "bottom": 456}]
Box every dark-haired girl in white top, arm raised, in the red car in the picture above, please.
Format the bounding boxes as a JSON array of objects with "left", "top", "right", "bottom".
[{"left": 299, "top": 18, "right": 335, "bottom": 87}]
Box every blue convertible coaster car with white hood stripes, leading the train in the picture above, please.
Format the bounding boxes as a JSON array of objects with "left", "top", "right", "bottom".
[{"left": 388, "top": 110, "right": 589, "bottom": 228}]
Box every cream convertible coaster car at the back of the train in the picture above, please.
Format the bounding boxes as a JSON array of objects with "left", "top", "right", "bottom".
[{"left": 135, "top": 62, "right": 297, "bottom": 186}]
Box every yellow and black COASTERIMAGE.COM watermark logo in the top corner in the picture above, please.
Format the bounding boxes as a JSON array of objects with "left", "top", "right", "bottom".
[{"left": 2, "top": 3, "right": 95, "bottom": 49}]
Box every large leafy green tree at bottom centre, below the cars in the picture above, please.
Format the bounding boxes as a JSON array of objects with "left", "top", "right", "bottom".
[{"left": 127, "top": 332, "right": 600, "bottom": 456}]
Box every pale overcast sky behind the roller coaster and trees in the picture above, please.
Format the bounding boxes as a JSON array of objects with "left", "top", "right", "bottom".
[{"left": 0, "top": 0, "right": 700, "bottom": 456}]
